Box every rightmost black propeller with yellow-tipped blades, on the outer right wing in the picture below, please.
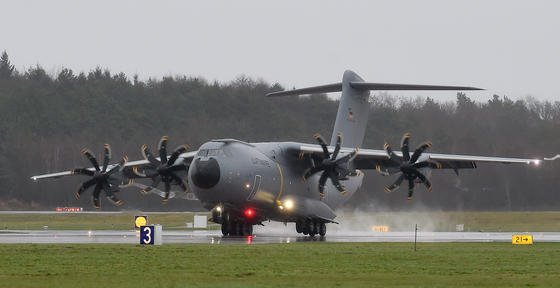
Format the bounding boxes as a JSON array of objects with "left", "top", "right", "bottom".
[{"left": 382, "top": 133, "right": 441, "bottom": 200}]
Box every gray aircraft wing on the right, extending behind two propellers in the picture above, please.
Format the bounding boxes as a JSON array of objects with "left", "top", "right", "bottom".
[{"left": 300, "top": 144, "right": 560, "bottom": 171}]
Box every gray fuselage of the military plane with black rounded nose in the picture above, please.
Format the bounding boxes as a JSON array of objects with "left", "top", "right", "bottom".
[{"left": 188, "top": 139, "right": 363, "bottom": 223}]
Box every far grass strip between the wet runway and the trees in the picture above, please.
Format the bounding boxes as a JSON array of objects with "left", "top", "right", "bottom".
[{"left": 0, "top": 211, "right": 560, "bottom": 232}]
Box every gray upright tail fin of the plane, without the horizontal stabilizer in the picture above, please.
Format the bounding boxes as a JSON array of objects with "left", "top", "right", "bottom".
[{"left": 331, "top": 70, "right": 369, "bottom": 148}]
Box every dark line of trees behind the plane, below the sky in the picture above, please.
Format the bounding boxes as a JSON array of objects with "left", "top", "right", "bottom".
[{"left": 0, "top": 52, "right": 560, "bottom": 210}]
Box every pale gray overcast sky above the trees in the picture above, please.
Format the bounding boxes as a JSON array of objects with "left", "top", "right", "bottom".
[{"left": 0, "top": 0, "right": 560, "bottom": 100}]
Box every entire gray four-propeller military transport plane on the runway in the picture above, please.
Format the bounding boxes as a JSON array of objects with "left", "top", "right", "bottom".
[{"left": 31, "top": 71, "right": 556, "bottom": 236}]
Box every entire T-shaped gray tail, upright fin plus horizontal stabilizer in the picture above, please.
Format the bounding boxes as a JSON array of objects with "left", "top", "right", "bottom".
[{"left": 267, "top": 70, "right": 484, "bottom": 148}]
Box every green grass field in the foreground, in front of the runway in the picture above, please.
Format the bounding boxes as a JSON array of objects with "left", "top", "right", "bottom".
[{"left": 0, "top": 242, "right": 560, "bottom": 287}]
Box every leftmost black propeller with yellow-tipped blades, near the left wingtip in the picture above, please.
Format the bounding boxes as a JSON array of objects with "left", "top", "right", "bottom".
[{"left": 72, "top": 144, "right": 128, "bottom": 209}]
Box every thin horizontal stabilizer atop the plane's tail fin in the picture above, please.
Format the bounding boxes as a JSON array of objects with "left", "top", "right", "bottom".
[{"left": 266, "top": 82, "right": 484, "bottom": 97}]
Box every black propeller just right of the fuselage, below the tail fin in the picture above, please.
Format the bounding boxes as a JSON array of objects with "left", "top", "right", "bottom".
[{"left": 303, "top": 133, "right": 358, "bottom": 198}]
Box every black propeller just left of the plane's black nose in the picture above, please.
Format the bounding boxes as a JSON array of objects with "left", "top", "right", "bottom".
[{"left": 133, "top": 136, "right": 188, "bottom": 204}]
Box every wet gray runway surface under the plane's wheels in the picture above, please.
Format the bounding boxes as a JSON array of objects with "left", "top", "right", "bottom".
[{"left": 0, "top": 227, "right": 560, "bottom": 244}]
